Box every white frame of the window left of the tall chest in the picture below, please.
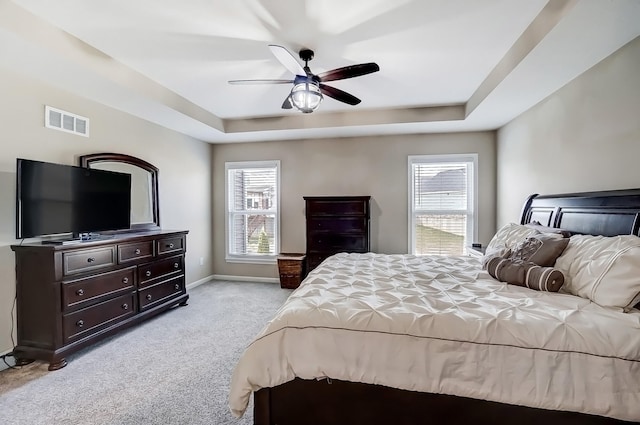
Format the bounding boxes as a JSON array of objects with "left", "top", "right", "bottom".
[{"left": 224, "top": 160, "right": 281, "bottom": 264}]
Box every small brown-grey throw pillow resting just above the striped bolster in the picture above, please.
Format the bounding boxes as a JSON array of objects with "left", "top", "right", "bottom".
[{"left": 509, "top": 233, "right": 569, "bottom": 267}]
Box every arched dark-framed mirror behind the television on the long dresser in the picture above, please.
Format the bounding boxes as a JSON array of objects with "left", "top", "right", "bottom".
[{"left": 80, "top": 153, "right": 160, "bottom": 230}]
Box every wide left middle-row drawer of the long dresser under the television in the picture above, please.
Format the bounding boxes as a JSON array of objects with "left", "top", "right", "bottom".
[{"left": 62, "top": 267, "right": 136, "bottom": 311}]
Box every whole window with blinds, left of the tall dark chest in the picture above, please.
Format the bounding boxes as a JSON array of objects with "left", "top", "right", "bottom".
[{"left": 225, "top": 161, "right": 280, "bottom": 263}]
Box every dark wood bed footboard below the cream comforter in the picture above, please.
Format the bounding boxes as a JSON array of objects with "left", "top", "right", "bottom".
[{"left": 254, "top": 378, "right": 631, "bottom": 425}]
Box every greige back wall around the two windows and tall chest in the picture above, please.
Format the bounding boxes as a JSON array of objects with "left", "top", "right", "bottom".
[{"left": 212, "top": 132, "right": 496, "bottom": 278}]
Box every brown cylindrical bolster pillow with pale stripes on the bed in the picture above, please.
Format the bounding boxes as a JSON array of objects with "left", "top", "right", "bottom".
[{"left": 487, "top": 257, "right": 564, "bottom": 292}]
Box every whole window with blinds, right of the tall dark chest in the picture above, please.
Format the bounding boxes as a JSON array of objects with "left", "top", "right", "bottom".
[{"left": 409, "top": 154, "right": 478, "bottom": 255}]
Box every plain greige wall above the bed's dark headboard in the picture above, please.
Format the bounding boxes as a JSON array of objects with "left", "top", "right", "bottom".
[{"left": 497, "top": 38, "right": 640, "bottom": 226}]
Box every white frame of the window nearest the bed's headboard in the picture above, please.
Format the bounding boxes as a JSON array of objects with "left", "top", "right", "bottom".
[{"left": 407, "top": 153, "right": 478, "bottom": 255}]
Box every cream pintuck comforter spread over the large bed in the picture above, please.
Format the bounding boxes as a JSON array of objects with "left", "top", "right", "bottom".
[{"left": 230, "top": 253, "right": 640, "bottom": 421}]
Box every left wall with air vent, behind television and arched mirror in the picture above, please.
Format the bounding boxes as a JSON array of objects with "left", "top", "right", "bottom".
[{"left": 0, "top": 68, "right": 212, "bottom": 353}]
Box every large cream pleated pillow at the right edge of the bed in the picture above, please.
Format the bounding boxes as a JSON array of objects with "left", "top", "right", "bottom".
[{"left": 555, "top": 235, "right": 640, "bottom": 311}]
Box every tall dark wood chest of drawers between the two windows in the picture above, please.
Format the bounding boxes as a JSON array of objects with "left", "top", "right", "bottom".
[{"left": 304, "top": 196, "right": 371, "bottom": 272}]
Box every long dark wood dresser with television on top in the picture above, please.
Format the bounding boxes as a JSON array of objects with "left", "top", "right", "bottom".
[{"left": 11, "top": 230, "right": 189, "bottom": 370}]
